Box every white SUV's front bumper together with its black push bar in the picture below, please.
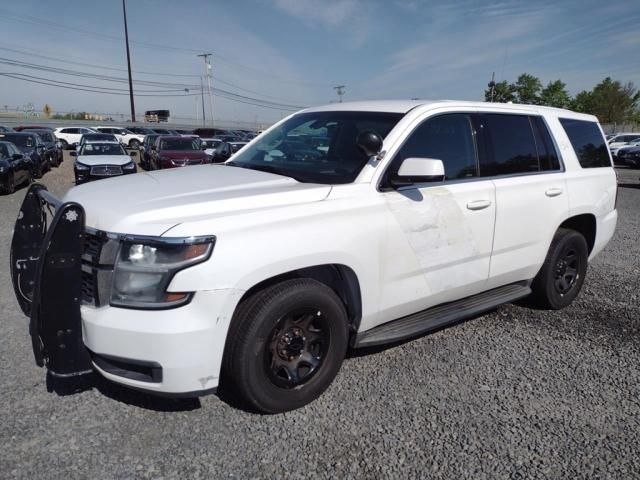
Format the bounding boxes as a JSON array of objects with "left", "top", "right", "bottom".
[{"left": 11, "top": 184, "right": 243, "bottom": 396}]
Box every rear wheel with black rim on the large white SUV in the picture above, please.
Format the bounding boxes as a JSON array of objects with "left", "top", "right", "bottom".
[{"left": 531, "top": 228, "right": 589, "bottom": 310}]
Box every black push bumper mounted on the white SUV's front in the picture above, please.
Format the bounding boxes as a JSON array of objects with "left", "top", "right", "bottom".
[{"left": 10, "top": 183, "right": 92, "bottom": 377}]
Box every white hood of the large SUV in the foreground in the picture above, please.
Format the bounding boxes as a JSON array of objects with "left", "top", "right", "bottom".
[{"left": 64, "top": 165, "right": 331, "bottom": 235}]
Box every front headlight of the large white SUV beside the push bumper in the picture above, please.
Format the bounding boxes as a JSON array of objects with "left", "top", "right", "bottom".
[{"left": 111, "top": 237, "right": 215, "bottom": 309}]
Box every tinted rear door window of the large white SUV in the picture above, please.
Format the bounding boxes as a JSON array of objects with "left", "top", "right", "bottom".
[{"left": 480, "top": 113, "right": 540, "bottom": 177}]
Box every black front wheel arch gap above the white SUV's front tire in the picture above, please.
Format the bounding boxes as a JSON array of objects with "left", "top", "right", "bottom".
[{"left": 236, "top": 263, "right": 362, "bottom": 334}]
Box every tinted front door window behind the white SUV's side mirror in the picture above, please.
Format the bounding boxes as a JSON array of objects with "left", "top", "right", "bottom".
[{"left": 389, "top": 114, "right": 477, "bottom": 179}]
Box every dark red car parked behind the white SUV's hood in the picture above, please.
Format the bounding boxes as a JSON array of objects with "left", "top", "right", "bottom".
[{"left": 150, "top": 135, "right": 211, "bottom": 170}]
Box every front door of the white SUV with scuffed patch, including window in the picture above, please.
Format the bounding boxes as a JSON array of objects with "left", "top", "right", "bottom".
[{"left": 380, "top": 113, "right": 496, "bottom": 320}]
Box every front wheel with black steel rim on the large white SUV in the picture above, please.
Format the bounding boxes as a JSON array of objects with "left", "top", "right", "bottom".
[{"left": 223, "top": 279, "right": 349, "bottom": 413}]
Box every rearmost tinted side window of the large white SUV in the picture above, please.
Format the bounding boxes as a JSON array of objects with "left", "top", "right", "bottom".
[{"left": 560, "top": 118, "right": 611, "bottom": 168}]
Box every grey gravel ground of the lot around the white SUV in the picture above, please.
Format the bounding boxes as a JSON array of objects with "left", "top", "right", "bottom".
[{"left": 0, "top": 158, "right": 640, "bottom": 479}]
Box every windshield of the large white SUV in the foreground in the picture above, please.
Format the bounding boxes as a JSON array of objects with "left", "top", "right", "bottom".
[{"left": 227, "top": 112, "right": 403, "bottom": 184}]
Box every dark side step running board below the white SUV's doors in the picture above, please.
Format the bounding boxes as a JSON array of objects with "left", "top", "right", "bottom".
[{"left": 355, "top": 282, "right": 531, "bottom": 348}]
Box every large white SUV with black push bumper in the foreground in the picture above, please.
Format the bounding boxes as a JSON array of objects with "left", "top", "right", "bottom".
[{"left": 12, "top": 101, "right": 617, "bottom": 412}]
